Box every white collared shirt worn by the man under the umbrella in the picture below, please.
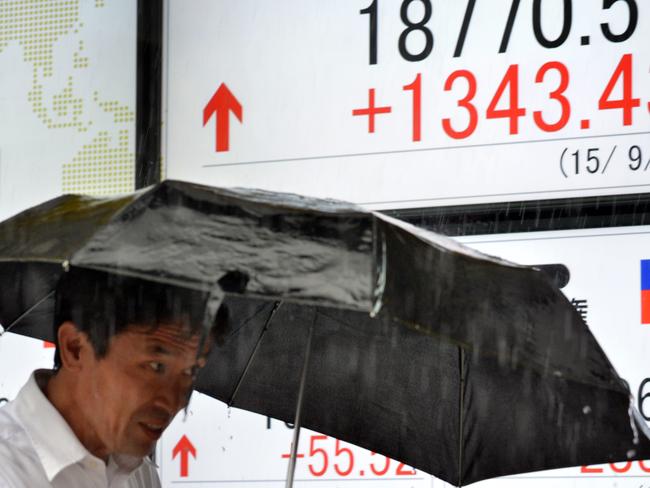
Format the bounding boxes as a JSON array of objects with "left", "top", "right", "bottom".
[{"left": 0, "top": 370, "right": 160, "bottom": 488}]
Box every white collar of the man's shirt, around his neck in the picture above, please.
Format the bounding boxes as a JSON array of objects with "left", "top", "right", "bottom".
[{"left": 15, "top": 369, "right": 146, "bottom": 482}]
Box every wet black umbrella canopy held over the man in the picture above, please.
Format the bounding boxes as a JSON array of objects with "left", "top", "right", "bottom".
[{"left": 0, "top": 181, "right": 650, "bottom": 485}]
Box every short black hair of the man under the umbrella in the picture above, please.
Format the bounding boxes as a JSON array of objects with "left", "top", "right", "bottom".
[{"left": 54, "top": 267, "right": 228, "bottom": 369}]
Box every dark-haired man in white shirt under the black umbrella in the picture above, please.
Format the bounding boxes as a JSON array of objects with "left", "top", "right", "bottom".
[{"left": 0, "top": 269, "right": 226, "bottom": 488}]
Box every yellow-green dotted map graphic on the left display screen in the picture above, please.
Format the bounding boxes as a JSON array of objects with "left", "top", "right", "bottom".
[{"left": 0, "top": 0, "right": 135, "bottom": 195}]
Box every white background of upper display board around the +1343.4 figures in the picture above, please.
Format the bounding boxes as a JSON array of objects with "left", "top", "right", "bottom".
[{"left": 164, "top": 0, "right": 650, "bottom": 208}]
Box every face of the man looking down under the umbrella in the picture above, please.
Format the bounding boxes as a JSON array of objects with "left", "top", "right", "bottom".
[{"left": 80, "top": 325, "right": 205, "bottom": 457}]
